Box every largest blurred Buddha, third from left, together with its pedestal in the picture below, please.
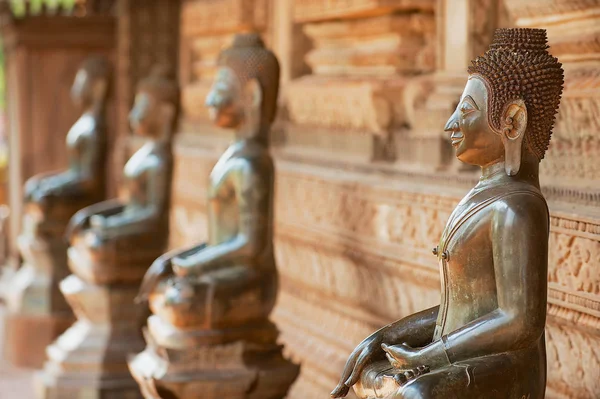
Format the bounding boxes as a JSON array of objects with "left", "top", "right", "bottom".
[{"left": 130, "top": 34, "right": 298, "bottom": 399}]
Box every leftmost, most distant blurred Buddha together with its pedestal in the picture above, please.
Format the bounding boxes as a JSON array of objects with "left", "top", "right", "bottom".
[{"left": 5, "top": 57, "right": 111, "bottom": 368}]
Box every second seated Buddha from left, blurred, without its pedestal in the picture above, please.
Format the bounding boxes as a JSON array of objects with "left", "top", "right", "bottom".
[{"left": 67, "top": 67, "right": 179, "bottom": 284}]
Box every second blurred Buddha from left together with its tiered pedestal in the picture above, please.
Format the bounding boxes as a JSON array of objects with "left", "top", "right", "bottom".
[{"left": 41, "top": 69, "right": 179, "bottom": 399}]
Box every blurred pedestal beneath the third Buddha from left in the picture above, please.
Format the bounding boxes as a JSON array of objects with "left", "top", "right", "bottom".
[{"left": 129, "top": 316, "right": 299, "bottom": 399}]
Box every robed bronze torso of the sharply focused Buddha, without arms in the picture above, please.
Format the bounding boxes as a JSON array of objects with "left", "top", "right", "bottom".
[{"left": 433, "top": 182, "right": 544, "bottom": 340}]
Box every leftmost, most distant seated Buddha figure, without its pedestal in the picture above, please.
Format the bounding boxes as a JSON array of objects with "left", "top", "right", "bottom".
[{"left": 24, "top": 56, "right": 111, "bottom": 230}]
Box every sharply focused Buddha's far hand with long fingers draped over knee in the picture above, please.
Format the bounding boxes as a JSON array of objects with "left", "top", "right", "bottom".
[{"left": 331, "top": 326, "right": 389, "bottom": 398}]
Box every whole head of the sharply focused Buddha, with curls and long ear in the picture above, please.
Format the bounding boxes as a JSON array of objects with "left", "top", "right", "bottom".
[{"left": 445, "top": 28, "right": 564, "bottom": 176}]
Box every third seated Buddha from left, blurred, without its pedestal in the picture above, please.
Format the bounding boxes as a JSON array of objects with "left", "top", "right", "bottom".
[{"left": 141, "top": 35, "right": 279, "bottom": 346}]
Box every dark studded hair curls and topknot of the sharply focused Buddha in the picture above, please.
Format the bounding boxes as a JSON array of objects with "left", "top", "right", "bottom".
[{"left": 468, "top": 28, "right": 564, "bottom": 160}]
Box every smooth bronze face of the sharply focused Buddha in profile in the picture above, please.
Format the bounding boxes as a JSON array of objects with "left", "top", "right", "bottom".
[{"left": 445, "top": 76, "right": 504, "bottom": 167}]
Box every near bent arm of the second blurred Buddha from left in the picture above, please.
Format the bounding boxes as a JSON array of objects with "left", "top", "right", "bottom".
[{"left": 92, "top": 165, "right": 169, "bottom": 238}]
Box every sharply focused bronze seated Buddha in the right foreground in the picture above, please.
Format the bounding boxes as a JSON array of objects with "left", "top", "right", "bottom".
[{"left": 332, "top": 29, "right": 563, "bottom": 399}]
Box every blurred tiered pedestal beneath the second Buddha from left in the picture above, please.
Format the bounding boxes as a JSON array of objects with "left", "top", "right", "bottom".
[{"left": 38, "top": 275, "right": 147, "bottom": 399}]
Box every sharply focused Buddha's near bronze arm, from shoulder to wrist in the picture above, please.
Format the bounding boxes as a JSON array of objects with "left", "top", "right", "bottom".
[{"left": 443, "top": 195, "right": 549, "bottom": 362}]
